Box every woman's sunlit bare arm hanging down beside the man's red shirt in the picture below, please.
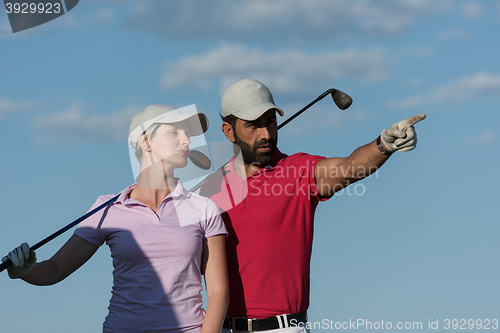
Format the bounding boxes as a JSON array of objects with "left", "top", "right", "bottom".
[{"left": 201, "top": 234, "right": 229, "bottom": 333}]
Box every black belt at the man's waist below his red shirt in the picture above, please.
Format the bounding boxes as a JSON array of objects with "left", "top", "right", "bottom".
[{"left": 222, "top": 311, "right": 307, "bottom": 332}]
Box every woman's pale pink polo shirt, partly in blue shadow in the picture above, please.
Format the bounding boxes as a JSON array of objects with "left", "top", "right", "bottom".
[{"left": 75, "top": 181, "right": 227, "bottom": 332}]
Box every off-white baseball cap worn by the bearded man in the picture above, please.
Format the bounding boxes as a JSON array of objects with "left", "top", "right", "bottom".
[{"left": 221, "top": 79, "right": 283, "bottom": 121}]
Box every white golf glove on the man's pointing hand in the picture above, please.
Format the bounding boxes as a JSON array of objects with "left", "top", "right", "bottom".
[{"left": 380, "top": 113, "right": 425, "bottom": 153}]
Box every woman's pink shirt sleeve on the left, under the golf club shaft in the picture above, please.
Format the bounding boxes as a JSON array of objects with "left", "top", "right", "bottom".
[{"left": 74, "top": 195, "right": 113, "bottom": 246}]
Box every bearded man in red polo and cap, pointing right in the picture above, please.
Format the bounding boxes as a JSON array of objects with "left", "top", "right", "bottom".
[{"left": 201, "top": 79, "right": 425, "bottom": 332}]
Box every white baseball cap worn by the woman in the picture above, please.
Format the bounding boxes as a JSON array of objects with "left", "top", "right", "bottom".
[{"left": 128, "top": 104, "right": 208, "bottom": 143}]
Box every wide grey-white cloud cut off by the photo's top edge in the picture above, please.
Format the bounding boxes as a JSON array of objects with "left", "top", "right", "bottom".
[{"left": 124, "top": 0, "right": 449, "bottom": 43}]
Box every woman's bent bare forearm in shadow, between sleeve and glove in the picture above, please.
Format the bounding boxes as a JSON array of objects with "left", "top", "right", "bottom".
[{"left": 21, "top": 235, "right": 99, "bottom": 286}]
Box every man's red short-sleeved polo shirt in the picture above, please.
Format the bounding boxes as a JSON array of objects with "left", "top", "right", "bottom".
[{"left": 200, "top": 151, "right": 326, "bottom": 318}]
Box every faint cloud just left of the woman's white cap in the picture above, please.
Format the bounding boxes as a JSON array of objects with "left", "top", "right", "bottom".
[{"left": 34, "top": 105, "right": 140, "bottom": 141}]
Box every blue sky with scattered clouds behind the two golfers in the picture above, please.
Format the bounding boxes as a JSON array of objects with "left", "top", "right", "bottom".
[{"left": 0, "top": 0, "right": 500, "bottom": 332}]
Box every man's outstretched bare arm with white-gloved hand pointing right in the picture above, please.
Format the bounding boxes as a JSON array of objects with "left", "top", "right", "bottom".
[{"left": 314, "top": 114, "right": 425, "bottom": 197}]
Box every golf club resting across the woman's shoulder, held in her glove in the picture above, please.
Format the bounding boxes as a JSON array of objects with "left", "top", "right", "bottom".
[{"left": 0, "top": 150, "right": 212, "bottom": 272}]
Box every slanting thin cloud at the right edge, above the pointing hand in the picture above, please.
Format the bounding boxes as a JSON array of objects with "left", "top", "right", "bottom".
[{"left": 389, "top": 72, "right": 500, "bottom": 110}]
